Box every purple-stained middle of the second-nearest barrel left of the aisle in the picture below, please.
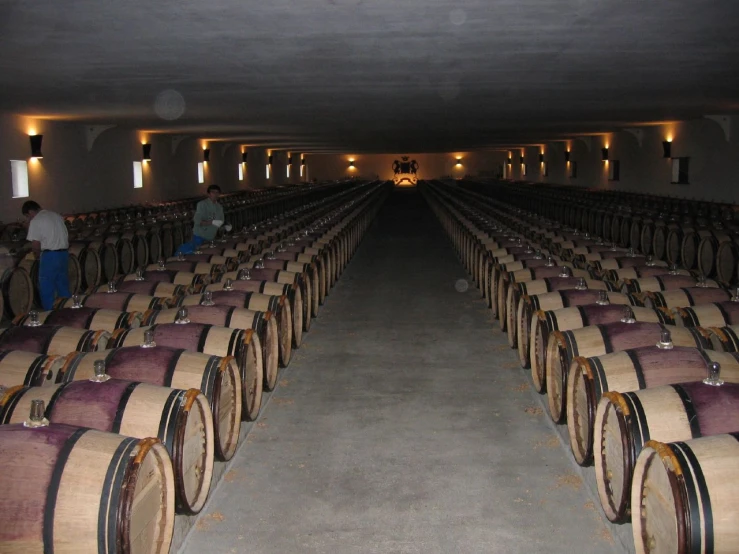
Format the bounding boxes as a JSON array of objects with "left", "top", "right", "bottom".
[{"left": 46, "top": 379, "right": 131, "bottom": 433}]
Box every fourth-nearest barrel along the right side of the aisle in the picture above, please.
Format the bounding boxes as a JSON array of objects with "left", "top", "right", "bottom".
[{"left": 546, "top": 322, "right": 711, "bottom": 423}]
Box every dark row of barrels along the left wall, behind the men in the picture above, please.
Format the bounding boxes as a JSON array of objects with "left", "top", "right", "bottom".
[{"left": 0, "top": 179, "right": 370, "bottom": 318}]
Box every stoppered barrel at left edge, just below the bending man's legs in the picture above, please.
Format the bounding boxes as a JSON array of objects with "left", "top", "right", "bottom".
[{"left": 0, "top": 325, "right": 111, "bottom": 356}]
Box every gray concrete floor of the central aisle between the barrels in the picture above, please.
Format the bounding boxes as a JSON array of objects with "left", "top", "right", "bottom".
[{"left": 181, "top": 191, "right": 631, "bottom": 554}]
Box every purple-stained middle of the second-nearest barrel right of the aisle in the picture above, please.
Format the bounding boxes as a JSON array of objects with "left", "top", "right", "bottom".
[{"left": 679, "top": 381, "right": 739, "bottom": 436}]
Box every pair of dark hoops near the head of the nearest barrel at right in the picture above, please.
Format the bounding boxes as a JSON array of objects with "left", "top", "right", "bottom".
[{"left": 671, "top": 441, "right": 713, "bottom": 554}]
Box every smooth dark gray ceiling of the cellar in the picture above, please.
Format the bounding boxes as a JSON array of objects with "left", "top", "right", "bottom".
[{"left": 0, "top": 0, "right": 739, "bottom": 153}]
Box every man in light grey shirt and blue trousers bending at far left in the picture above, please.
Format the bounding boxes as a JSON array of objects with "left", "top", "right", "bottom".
[{"left": 21, "top": 200, "right": 70, "bottom": 310}]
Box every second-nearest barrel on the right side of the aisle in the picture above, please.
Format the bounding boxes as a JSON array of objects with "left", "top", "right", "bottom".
[{"left": 595, "top": 381, "right": 739, "bottom": 523}]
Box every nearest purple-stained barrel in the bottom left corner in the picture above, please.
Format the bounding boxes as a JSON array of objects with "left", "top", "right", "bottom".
[{"left": 0, "top": 424, "right": 175, "bottom": 554}]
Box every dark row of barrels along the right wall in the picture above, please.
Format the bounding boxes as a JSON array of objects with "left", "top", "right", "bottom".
[{"left": 461, "top": 182, "right": 739, "bottom": 285}]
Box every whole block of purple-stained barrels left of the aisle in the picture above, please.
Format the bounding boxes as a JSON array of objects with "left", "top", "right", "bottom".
[{"left": 0, "top": 184, "right": 388, "bottom": 553}]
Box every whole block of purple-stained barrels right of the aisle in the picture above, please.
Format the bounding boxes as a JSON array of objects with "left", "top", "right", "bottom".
[{"left": 425, "top": 180, "right": 739, "bottom": 552}]
